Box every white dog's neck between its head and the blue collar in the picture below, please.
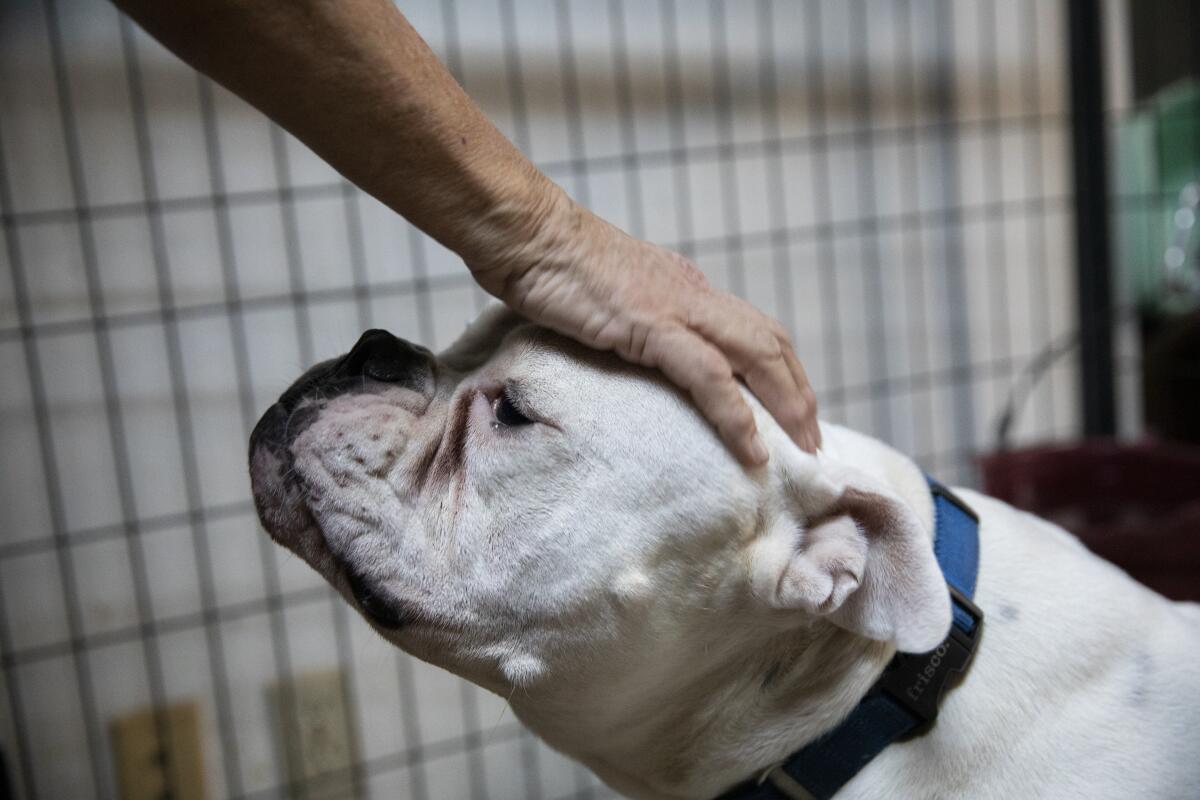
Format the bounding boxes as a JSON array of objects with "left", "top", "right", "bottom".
[{"left": 512, "top": 427, "right": 934, "bottom": 798}]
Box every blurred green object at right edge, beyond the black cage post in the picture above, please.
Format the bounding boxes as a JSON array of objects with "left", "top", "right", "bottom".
[{"left": 1115, "top": 78, "right": 1200, "bottom": 314}]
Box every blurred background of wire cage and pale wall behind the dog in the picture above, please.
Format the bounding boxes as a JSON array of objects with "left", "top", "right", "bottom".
[{"left": 0, "top": 0, "right": 1200, "bottom": 799}]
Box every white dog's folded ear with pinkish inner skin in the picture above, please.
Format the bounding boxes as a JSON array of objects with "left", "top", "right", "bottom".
[{"left": 751, "top": 456, "right": 950, "bottom": 652}]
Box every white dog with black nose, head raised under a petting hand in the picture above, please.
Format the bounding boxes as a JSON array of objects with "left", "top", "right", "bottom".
[{"left": 251, "top": 304, "right": 1200, "bottom": 799}]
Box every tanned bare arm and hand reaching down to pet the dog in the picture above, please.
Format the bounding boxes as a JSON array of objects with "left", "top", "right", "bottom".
[{"left": 116, "top": 0, "right": 820, "bottom": 465}]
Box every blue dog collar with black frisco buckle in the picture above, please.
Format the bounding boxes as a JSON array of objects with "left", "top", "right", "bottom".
[{"left": 719, "top": 477, "right": 983, "bottom": 800}]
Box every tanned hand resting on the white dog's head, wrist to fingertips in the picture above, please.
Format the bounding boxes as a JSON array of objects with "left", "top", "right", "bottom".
[{"left": 469, "top": 194, "right": 821, "bottom": 465}]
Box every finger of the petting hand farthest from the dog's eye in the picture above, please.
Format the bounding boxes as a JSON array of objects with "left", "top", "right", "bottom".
[{"left": 689, "top": 293, "right": 820, "bottom": 452}]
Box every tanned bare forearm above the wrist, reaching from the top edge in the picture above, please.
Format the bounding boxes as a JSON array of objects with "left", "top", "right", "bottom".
[{"left": 116, "top": 0, "right": 570, "bottom": 272}]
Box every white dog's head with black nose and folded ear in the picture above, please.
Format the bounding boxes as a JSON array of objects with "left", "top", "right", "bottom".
[{"left": 250, "top": 308, "right": 949, "bottom": 694}]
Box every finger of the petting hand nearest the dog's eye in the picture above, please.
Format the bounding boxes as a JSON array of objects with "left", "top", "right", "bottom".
[{"left": 644, "top": 326, "right": 768, "bottom": 467}]
